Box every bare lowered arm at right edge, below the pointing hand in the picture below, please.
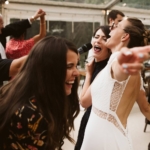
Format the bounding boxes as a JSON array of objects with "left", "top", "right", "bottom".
[{"left": 137, "top": 90, "right": 150, "bottom": 120}]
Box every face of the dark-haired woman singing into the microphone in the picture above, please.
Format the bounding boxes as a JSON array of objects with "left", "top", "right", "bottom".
[{"left": 92, "top": 29, "right": 110, "bottom": 62}]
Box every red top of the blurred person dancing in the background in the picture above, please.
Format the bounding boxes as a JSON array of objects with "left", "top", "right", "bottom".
[{"left": 6, "top": 38, "right": 34, "bottom": 59}]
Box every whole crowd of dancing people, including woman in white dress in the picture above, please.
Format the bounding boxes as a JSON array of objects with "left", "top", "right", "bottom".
[{"left": 0, "top": 9, "right": 150, "bottom": 150}]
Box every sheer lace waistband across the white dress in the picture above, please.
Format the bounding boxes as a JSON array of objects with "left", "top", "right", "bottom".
[{"left": 92, "top": 106, "right": 126, "bottom": 135}]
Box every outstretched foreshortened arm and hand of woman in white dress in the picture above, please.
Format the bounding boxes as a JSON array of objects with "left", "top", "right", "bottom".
[{"left": 111, "top": 46, "right": 150, "bottom": 81}]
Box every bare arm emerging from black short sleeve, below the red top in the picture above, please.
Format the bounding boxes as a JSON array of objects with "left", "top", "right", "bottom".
[{"left": 9, "top": 56, "right": 27, "bottom": 77}]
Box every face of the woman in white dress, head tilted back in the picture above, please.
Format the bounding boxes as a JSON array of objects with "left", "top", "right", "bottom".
[{"left": 106, "top": 19, "right": 129, "bottom": 49}]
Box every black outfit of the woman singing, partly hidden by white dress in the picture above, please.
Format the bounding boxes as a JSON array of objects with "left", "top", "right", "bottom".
[{"left": 74, "top": 58, "right": 109, "bottom": 150}]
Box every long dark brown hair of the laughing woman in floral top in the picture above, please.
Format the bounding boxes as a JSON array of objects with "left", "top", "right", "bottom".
[{"left": 0, "top": 36, "right": 79, "bottom": 150}]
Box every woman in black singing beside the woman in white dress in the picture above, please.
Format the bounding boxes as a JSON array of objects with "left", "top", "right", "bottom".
[{"left": 75, "top": 26, "right": 111, "bottom": 150}]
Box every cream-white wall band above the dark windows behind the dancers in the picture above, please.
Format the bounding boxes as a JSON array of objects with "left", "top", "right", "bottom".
[{"left": 2, "top": 0, "right": 104, "bottom": 24}]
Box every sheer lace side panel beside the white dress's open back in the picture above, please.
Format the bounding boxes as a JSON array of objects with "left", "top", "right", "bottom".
[{"left": 110, "top": 82, "right": 126, "bottom": 111}]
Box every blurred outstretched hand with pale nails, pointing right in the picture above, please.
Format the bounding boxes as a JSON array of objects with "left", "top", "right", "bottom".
[{"left": 118, "top": 46, "right": 150, "bottom": 75}]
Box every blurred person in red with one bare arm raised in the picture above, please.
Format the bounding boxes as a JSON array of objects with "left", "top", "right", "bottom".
[{"left": 6, "top": 9, "right": 46, "bottom": 59}]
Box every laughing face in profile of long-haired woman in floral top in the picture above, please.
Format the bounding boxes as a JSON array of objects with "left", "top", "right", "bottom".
[{"left": 65, "top": 50, "right": 79, "bottom": 95}]
